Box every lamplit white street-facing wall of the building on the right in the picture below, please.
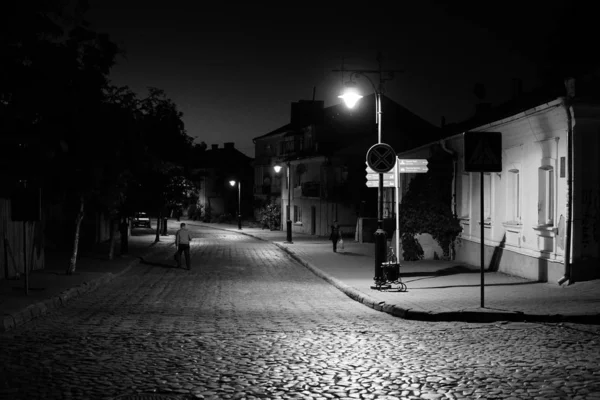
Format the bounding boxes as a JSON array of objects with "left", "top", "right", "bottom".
[{"left": 399, "top": 100, "right": 575, "bottom": 281}]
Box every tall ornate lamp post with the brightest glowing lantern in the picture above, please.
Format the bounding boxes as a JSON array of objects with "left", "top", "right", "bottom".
[{"left": 333, "top": 54, "right": 399, "bottom": 289}]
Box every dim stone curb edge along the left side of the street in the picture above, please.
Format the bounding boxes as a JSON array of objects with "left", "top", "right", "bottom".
[{"left": 0, "top": 257, "right": 146, "bottom": 332}]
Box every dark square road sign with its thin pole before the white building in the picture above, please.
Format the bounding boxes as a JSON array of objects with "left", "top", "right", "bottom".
[{"left": 463, "top": 132, "right": 502, "bottom": 308}]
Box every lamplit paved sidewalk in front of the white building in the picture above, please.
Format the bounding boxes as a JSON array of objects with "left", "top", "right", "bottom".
[{"left": 187, "top": 221, "right": 600, "bottom": 324}]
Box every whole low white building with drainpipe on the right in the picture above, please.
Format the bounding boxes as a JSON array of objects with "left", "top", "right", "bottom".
[{"left": 398, "top": 85, "right": 600, "bottom": 283}]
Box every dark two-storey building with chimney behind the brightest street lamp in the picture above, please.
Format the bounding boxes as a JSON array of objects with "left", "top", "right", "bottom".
[{"left": 253, "top": 95, "right": 441, "bottom": 241}]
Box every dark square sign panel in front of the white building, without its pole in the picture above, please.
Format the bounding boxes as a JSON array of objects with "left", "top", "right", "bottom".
[{"left": 463, "top": 132, "right": 502, "bottom": 172}]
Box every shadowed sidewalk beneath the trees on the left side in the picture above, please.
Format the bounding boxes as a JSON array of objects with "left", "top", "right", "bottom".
[{"left": 0, "top": 221, "right": 177, "bottom": 332}]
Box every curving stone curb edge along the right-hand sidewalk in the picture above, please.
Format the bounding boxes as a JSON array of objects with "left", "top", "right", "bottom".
[{"left": 155, "top": 223, "right": 600, "bottom": 325}]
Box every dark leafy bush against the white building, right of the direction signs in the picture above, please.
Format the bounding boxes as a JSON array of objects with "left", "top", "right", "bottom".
[{"left": 399, "top": 149, "right": 462, "bottom": 260}]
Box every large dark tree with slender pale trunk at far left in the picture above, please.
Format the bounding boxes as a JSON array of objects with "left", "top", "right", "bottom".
[{"left": 0, "top": 0, "right": 124, "bottom": 274}]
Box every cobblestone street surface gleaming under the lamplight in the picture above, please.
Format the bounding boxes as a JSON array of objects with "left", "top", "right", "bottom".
[{"left": 0, "top": 228, "right": 600, "bottom": 399}]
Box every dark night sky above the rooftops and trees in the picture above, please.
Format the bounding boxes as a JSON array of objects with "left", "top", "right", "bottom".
[{"left": 86, "top": 0, "right": 584, "bottom": 157}]
